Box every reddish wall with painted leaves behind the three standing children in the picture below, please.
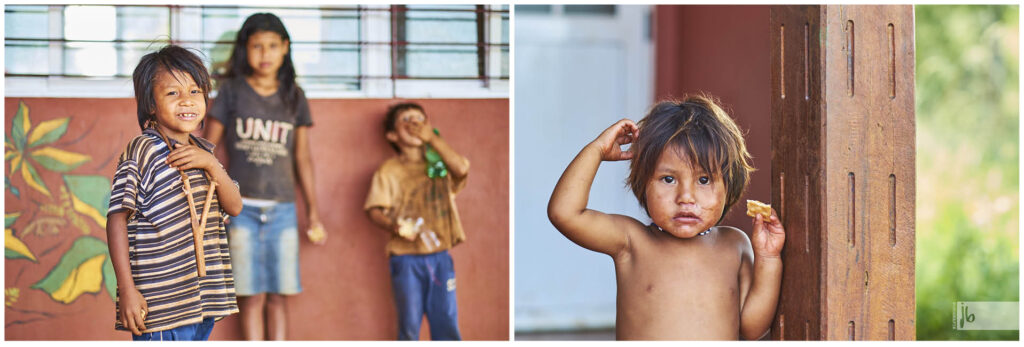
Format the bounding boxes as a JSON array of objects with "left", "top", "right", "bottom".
[{"left": 4, "top": 98, "right": 509, "bottom": 340}]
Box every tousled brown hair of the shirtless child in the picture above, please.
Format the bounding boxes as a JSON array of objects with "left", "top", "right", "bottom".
[{"left": 627, "top": 94, "right": 754, "bottom": 224}]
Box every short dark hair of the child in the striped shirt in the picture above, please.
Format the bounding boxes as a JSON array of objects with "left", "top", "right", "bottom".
[{"left": 131, "top": 45, "right": 212, "bottom": 130}]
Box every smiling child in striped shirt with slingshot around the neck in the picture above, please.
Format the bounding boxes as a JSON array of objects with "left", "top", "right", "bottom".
[{"left": 106, "top": 45, "right": 242, "bottom": 341}]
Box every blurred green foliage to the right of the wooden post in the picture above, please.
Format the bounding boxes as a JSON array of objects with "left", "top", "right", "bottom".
[{"left": 914, "top": 5, "right": 1020, "bottom": 340}]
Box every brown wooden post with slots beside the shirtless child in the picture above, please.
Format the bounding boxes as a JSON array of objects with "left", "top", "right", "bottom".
[{"left": 770, "top": 5, "right": 915, "bottom": 340}]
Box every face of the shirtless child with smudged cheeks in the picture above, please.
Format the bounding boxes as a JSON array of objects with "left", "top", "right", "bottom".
[{"left": 646, "top": 145, "right": 726, "bottom": 238}]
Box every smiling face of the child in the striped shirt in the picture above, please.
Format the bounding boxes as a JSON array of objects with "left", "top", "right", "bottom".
[{"left": 153, "top": 70, "right": 206, "bottom": 140}]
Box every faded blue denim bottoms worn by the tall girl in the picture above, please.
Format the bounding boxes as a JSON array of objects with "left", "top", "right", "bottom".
[{"left": 227, "top": 203, "right": 302, "bottom": 296}]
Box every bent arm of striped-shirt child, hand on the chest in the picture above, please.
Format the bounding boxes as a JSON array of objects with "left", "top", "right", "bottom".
[{"left": 167, "top": 143, "right": 242, "bottom": 216}]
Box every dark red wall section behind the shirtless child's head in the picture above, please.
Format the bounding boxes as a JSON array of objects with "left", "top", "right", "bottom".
[{"left": 653, "top": 5, "right": 771, "bottom": 232}]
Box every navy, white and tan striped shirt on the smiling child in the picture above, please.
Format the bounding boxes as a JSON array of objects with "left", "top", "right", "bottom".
[{"left": 108, "top": 129, "right": 239, "bottom": 333}]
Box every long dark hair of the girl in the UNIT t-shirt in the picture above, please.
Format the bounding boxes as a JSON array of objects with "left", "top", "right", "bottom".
[{"left": 224, "top": 12, "right": 299, "bottom": 112}]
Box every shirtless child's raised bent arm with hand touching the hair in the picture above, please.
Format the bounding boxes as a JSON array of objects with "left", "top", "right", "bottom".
[{"left": 548, "top": 119, "right": 639, "bottom": 257}]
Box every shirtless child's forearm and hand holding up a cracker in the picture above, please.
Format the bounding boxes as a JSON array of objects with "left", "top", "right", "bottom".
[{"left": 739, "top": 210, "right": 785, "bottom": 340}]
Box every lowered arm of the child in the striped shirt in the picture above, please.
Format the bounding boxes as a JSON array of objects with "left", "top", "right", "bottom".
[{"left": 106, "top": 212, "right": 150, "bottom": 336}]
